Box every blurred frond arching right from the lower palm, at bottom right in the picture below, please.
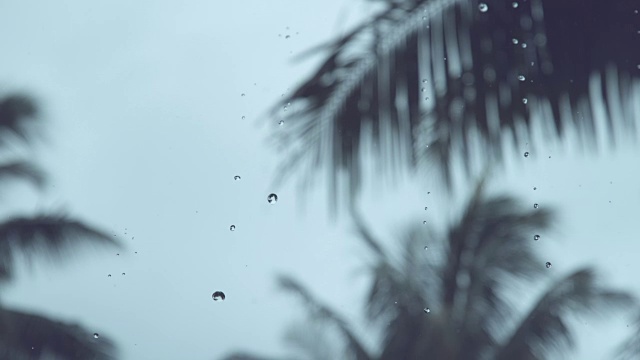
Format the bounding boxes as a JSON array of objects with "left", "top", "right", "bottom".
[{"left": 495, "top": 268, "right": 635, "bottom": 359}]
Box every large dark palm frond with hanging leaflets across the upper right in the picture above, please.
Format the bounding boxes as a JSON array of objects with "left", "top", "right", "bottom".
[{"left": 272, "top": 0, "right": 640, "bottom": 210}]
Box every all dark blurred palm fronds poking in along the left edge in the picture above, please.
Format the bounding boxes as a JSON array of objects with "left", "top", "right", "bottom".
[{"left": 0, "top": 95, "right": 120, "bottom": 360}]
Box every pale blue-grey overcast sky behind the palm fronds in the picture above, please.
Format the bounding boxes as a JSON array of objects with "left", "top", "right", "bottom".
[{"left": 0, "top": 0, "right": 640, "bottom": 359}]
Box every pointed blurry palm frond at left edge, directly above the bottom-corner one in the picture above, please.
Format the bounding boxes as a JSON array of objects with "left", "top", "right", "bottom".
[{"left": 0, "top": 214, "right": 120, "bottom": 280}]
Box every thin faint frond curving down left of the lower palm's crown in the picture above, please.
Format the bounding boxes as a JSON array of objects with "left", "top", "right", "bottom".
[{"left": 278, "top": 276, "right": 372, "bottom": 360}]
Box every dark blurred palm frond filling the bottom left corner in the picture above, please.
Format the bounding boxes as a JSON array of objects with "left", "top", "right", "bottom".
[{"left": 0, "top": 307, "right": 116, "bottom": 360}]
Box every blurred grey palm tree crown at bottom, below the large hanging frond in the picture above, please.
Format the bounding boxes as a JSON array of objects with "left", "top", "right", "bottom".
[{"left": 228, "top": 183, "right": 635, "bottom": 360}]
